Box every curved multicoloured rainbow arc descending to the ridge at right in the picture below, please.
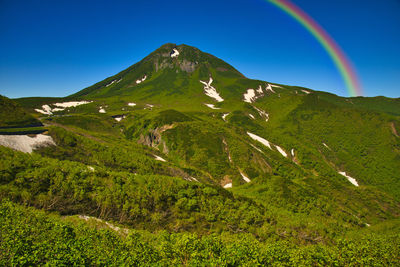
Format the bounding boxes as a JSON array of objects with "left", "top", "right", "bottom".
[{"left": 266, "top": 0, "right": 363, "bottom": 96}]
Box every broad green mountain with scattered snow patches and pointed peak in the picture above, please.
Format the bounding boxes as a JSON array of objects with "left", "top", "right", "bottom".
[{"left": 0, "top": 44, "right": 400, "bottom": 265}]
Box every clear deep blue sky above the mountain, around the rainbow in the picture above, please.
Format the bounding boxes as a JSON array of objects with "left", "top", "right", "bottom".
[{"left": 0, "top": 0, "right": 400, "bottom": 98}]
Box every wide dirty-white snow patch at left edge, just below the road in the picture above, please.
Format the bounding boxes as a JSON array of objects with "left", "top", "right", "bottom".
[{"left": 0, "top": 134, "right": 56, "bottom": 153}]
